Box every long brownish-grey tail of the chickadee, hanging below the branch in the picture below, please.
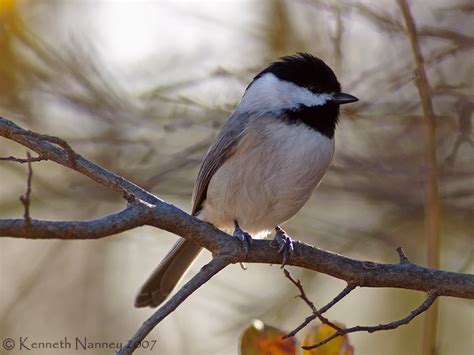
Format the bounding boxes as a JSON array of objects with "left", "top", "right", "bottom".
[{"left": 135, "top": 239, "right": 201, "bottom": 307}]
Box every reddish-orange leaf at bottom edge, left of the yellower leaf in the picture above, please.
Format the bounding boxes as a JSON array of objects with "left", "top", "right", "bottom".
[{"left": 240, "top": 320, "right": 296, "bottom": 355}]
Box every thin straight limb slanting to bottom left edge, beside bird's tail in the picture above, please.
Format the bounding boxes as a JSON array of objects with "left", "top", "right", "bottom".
[{"left": 116, "top": 256, "right": 230, "bottom": 355}]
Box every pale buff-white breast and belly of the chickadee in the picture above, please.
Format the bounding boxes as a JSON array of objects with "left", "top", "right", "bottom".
[{"left": 199, "top": 118, "right": 334, "bottom": 237}]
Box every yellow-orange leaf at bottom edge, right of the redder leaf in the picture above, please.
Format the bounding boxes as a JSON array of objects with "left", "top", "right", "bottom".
[{"left": 303, "top": 322, "right": 354, "bottom": 355}]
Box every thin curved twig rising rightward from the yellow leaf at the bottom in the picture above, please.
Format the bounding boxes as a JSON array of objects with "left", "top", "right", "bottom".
[{"left": 302, "top": 291, "right": 438, "bottom": 350}]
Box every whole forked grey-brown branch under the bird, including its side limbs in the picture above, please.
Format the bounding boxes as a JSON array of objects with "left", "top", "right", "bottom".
[{"left": 0, "top": 118, "right": 474, "bottom": 354}]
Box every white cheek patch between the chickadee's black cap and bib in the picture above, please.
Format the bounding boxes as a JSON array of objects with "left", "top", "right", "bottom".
[{"left": 239, "top": 73, "right": 332, "bottom": 112}]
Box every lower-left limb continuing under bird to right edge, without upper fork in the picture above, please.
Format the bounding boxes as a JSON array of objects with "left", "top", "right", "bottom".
[{"left": 0, "top": 209, "right": 474, "bottom": 299}]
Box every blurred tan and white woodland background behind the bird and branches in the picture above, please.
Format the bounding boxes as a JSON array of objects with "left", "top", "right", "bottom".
[{"left": 0, "top": 0, "right": 474, "bottom": 355}]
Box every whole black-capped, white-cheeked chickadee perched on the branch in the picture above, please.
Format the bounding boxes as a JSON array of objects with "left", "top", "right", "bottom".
[{"left": 135, "top": 53, "right": 358, "bottom": 307}]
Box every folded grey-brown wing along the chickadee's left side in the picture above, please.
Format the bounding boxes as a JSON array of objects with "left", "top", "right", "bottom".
[{"left": 192, "top": 113, "right": 248, "bottom": 215}]
